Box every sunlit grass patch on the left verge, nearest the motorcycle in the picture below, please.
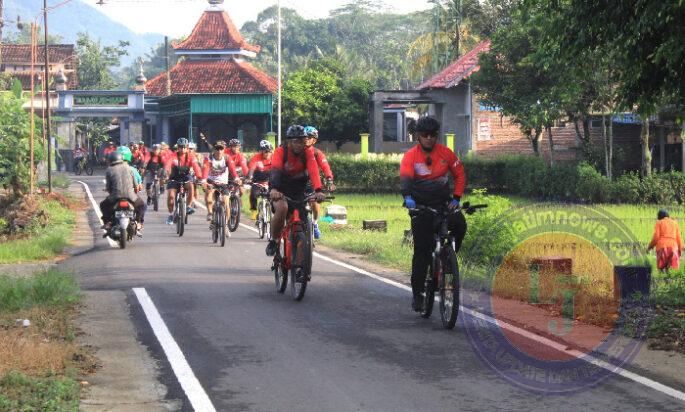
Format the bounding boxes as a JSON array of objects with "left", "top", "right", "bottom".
[{"left": 0, "top": 199, "right": 76, "bottom": 264}]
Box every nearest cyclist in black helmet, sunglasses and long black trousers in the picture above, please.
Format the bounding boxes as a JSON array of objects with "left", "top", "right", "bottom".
[{"left": 400, "top": 116, "right": 466, "bottom": 312}]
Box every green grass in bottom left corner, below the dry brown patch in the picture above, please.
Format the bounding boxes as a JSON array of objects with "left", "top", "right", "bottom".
[{"left": 0, "top": 371, "right": 80, "bottom": 412}]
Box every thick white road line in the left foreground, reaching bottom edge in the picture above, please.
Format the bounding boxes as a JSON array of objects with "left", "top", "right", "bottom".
[{"left": 133, "top": 288, "right": 216, "bottom": 412}]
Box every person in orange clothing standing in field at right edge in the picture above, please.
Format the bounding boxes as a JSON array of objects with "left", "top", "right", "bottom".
[{"left": 647, "top": 209, "right": 683, "bottom": 271}]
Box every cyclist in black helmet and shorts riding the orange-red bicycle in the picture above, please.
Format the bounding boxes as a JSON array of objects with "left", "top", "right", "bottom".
[{"left": 266, "top": 125, "right": 326, "bottom": 256}]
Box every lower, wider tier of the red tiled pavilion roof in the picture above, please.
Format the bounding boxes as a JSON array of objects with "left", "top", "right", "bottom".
[{"left": 145, "top": 60, "right": 278, "bottom": 96}]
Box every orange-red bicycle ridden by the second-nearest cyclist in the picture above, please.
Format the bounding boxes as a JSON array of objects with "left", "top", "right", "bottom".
[{"left": 271, "top": 194, "right": 334, "bottom": 302}]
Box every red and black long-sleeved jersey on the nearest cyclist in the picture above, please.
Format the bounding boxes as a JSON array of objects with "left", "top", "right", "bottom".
[{"left": 400, "top": 144, "right": 466, "bottom": 204}]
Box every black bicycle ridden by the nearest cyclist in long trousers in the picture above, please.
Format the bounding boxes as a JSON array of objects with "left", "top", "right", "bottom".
[{"left": 409, "top": 202, "right": 487, "bottom": 329}]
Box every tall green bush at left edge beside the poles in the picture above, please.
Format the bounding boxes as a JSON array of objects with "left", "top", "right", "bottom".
[{"left": 0, "top": 93, "right": 42, "bottom": 196}]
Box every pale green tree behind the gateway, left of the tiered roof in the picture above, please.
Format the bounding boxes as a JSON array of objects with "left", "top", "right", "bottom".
[{"left": 76, "top": 33, "right": 129, "bottom": 90}]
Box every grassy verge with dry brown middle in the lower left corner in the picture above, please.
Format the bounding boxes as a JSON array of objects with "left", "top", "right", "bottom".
[{"left": 0, "top": 270, "right": 88, "bottom": 411}]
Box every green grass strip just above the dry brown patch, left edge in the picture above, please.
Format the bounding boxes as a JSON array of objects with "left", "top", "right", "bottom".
[{"left": 0, "top": 269, "right": 81, "bottom": 312}]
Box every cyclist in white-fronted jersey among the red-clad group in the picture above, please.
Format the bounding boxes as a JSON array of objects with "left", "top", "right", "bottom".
[{"left": 202, "top": 140, "right": 241, "bottom": 222}]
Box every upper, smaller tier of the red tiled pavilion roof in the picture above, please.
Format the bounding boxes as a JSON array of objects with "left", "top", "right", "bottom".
[{"left": 172, "top": 10, "right": 261, "bottom": 53}]
